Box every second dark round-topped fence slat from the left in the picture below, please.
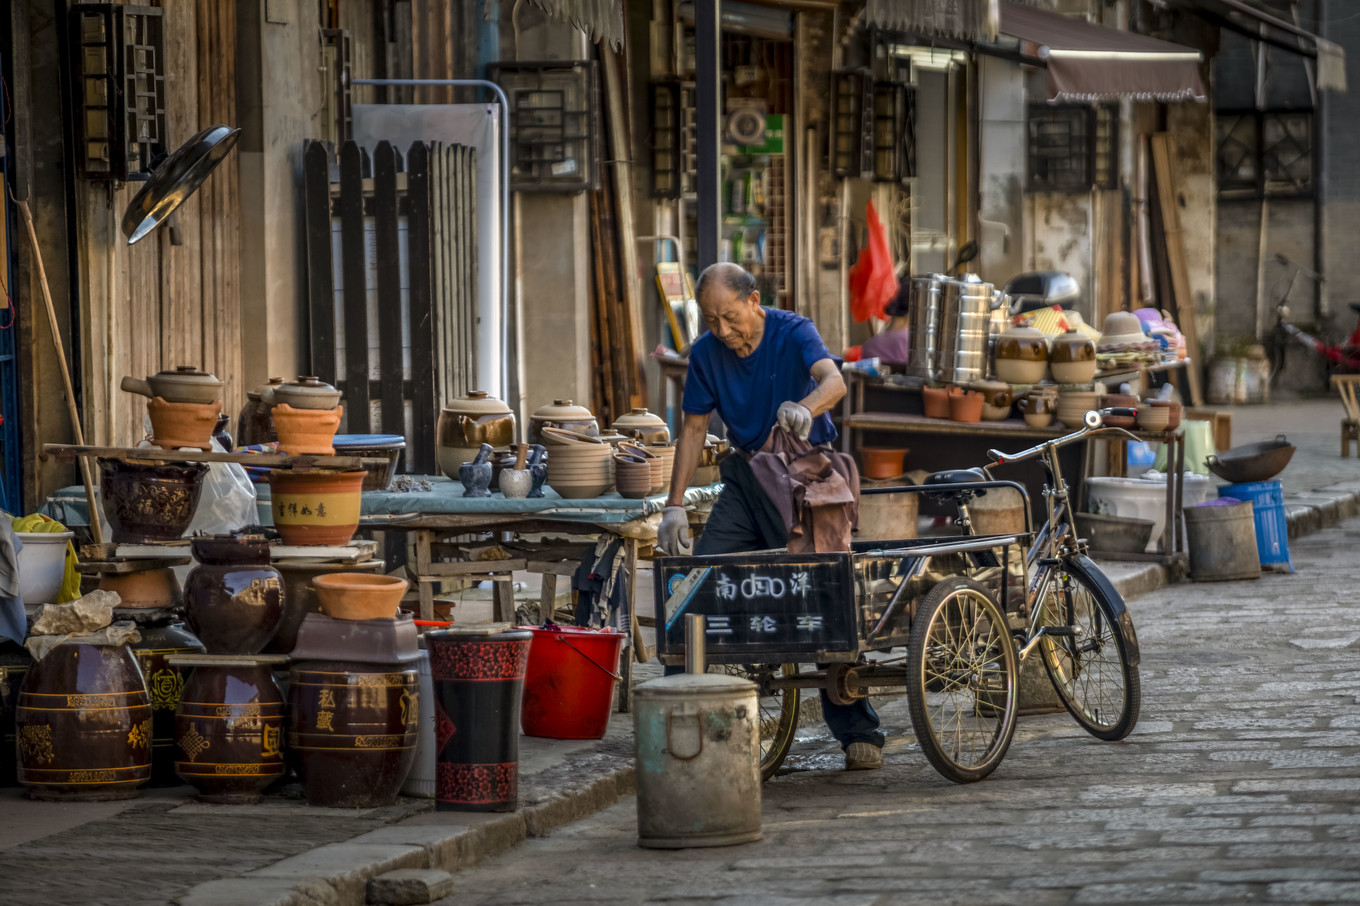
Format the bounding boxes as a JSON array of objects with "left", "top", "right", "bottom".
[{"left": 340, "top": 141, "right": 371, "bottom": 434}]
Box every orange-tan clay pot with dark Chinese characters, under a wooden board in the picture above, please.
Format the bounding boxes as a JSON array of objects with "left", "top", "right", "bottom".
[{"left": 269, "top": 469, "right": 367, "bottom": 546}]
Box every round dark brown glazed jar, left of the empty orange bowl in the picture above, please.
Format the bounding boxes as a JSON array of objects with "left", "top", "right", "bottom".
[{"left": 184, "top": 535, "right": 283, "bottom": 654}]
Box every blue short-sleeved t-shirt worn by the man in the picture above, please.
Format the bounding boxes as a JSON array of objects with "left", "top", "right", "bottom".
[{"left": 681, "top": 309, "right": 836, "bottom": 453}]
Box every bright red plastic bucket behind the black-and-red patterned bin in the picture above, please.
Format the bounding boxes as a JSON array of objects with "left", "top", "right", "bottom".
[{"left": 520, "top": 626, "right": 624, "bottom": 739}]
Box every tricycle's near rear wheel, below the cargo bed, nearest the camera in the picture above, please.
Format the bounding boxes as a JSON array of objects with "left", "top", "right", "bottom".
[{"left": 907, "top": 578, "right": 1019, "bottom": 784}]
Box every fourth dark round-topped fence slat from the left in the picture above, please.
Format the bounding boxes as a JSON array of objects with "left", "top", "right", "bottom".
[{"left": 405, "top": 141, "right": 441, "bottom": 475}]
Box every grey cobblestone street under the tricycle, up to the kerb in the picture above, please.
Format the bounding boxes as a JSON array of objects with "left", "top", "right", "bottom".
[{"left": 441, "top": 520, "right": 1360, "bottom": 906}]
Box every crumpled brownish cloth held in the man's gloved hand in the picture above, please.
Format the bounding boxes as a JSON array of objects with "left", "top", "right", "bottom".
[{"left": 751, "top": 427, "right": 860, "bottom": 554}]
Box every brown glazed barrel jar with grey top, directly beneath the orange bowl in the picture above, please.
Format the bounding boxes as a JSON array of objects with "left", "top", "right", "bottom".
[{"left": 288, "top": 615, "right": 420, "bottom": 808}]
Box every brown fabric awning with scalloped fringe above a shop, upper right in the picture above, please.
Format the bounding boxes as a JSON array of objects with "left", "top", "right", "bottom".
[{"left": 1001, "top": 0, "right": 1204, "bottom": 102}]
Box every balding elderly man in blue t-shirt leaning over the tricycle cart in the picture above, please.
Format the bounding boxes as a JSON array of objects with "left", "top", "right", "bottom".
[{"left": 657, "top": 264, "right": 883, "bottom": 770}]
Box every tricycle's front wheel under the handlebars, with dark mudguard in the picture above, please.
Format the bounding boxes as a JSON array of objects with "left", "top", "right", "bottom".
[{"left": 1039, "top": 560, "right": 1142, "bottom": 741}]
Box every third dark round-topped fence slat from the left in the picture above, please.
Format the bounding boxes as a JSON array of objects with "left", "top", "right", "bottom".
[{"left": 373, "top": 141, "right": 407, "bottom": 437}]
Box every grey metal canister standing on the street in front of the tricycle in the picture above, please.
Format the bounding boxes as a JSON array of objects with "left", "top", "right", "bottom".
[{"left": 634, "top": 673, "right": 760, "bottom": 849}]
